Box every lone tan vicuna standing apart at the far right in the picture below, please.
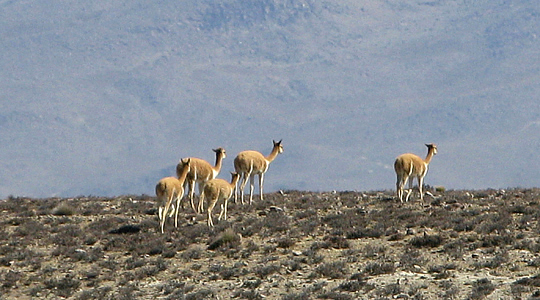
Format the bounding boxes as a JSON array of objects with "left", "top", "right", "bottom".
[{"left": 394, "top": 144, "right": 437, "bottom": 202}]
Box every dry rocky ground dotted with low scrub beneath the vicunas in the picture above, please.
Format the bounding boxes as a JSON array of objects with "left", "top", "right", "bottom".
[{"left": 0, "top": 189, "right": 540, "bottom": 300}]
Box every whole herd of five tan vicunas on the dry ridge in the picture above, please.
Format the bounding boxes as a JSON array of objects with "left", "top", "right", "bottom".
[{"left": 156, "top": 140, "right": 437, "bottom": 233}]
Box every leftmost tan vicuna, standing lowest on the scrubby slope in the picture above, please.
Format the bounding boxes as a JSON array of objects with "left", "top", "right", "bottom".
[{"left": 156, "top": 158, "right": 191, "bottom": 233}]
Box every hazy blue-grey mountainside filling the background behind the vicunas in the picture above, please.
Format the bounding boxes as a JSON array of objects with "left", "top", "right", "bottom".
[{"left": 0, "top": 0, "right": 540, "bottom": 197}]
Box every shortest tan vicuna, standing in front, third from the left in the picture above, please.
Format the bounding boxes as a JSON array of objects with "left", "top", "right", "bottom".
[{"left": 200, "top": 173, "right": 240, "bottom": 227}]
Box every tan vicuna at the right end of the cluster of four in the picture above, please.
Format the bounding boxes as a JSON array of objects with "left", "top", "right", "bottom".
[{"left": 234, "top": 140, "right": 283, "bottom": 204}]
